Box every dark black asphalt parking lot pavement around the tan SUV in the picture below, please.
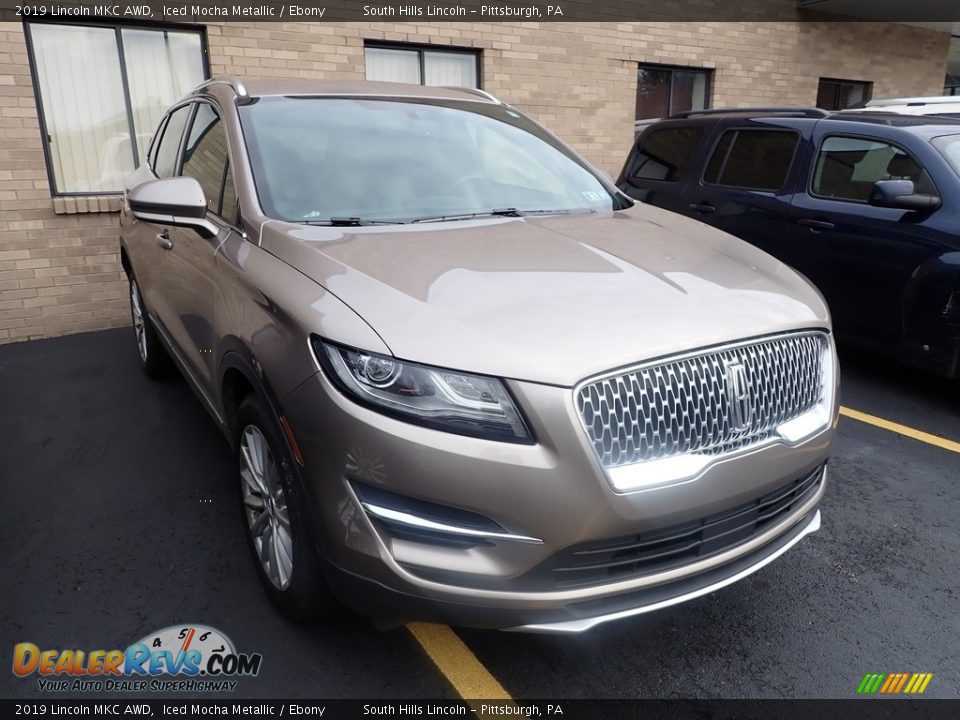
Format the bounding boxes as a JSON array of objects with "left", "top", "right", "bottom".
[{"left": 0, "top": 328, "right": 960, "bottom": 699}]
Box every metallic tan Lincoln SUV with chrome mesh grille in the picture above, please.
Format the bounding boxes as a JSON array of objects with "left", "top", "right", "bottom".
[{"left": 120, "top": 78, "right": 838, "bottom": 632}]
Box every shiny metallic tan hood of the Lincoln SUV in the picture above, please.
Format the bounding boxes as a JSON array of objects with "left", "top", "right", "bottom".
[{"left": 261, "top": 204, "right": 829, "bottom": 386}]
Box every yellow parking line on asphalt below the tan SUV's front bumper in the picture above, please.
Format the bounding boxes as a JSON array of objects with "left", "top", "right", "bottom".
[{"left": 407, "top": 623, "right": 513, "bottom": 701}]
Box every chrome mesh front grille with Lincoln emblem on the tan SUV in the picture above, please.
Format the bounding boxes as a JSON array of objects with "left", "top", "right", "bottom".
[{"left": 576, "top": 332, "right": 828, "bottom": 468}]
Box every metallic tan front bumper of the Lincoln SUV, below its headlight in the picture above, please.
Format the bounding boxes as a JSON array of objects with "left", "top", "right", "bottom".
[{"left": 283, "top": 360, "right": 836, "bottom": 633}]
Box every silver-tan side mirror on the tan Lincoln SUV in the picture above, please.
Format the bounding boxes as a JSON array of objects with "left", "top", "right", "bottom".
[{"left": 127, "top": 177, "right": 219, "bottom": 238}]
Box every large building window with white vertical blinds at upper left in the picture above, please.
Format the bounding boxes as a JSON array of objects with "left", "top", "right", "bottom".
[{"left": 28, "top": 23, "right": 207, "bottom": 195}]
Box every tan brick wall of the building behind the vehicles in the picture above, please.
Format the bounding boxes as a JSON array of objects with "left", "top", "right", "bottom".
[{"left": 0, "top": 17, "right": 949, "bottom": 343}]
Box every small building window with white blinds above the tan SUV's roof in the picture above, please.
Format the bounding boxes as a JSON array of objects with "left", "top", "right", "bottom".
[{"left": 364, "top": 45, "right": 480, "bottom": 88}]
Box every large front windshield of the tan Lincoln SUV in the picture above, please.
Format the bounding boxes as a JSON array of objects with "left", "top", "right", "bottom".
[{"left": 241, "top": 97, "right": 621, "bottom": 224}]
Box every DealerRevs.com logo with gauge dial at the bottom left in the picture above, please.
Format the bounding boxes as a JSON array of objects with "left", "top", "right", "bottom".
[{"left": 13, "top": 624, "right": 263, "bottom": 692}]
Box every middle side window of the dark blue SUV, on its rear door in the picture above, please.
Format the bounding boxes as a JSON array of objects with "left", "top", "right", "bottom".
[{"left": 703, "top": 130, "right": 800, "bottom": 191}]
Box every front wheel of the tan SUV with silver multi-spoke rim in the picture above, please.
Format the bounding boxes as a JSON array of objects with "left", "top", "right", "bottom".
[{"left": 234, "top": 394, "right": 336, "bottom": 620}]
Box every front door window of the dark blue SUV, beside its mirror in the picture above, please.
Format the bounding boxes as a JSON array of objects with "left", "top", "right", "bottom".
[{"left": 811, "top": 136, "right": 933, "bottom": 202}]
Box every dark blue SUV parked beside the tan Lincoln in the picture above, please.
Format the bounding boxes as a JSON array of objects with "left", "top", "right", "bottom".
[{"left": 617, "top": 109, "right": 960, "bottom": 377}]
